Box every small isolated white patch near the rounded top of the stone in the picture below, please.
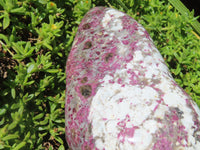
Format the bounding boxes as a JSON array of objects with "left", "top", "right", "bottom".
[{"left": 102, "top": 9, "right": 124, "bottom": 31}]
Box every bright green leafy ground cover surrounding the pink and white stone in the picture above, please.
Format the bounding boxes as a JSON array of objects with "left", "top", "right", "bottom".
[{"left": 0, "top": 0, "right": 200, "bottom": 150}]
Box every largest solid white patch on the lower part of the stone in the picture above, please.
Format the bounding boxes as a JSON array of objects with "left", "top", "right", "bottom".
[{"left": 89, "top": 75, "right": 159, "bottom": 150}]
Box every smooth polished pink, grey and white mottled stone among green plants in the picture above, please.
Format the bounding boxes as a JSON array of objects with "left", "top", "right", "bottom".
[{"left": 65, "top": 7, "right": 200, "bottom": 150}]
